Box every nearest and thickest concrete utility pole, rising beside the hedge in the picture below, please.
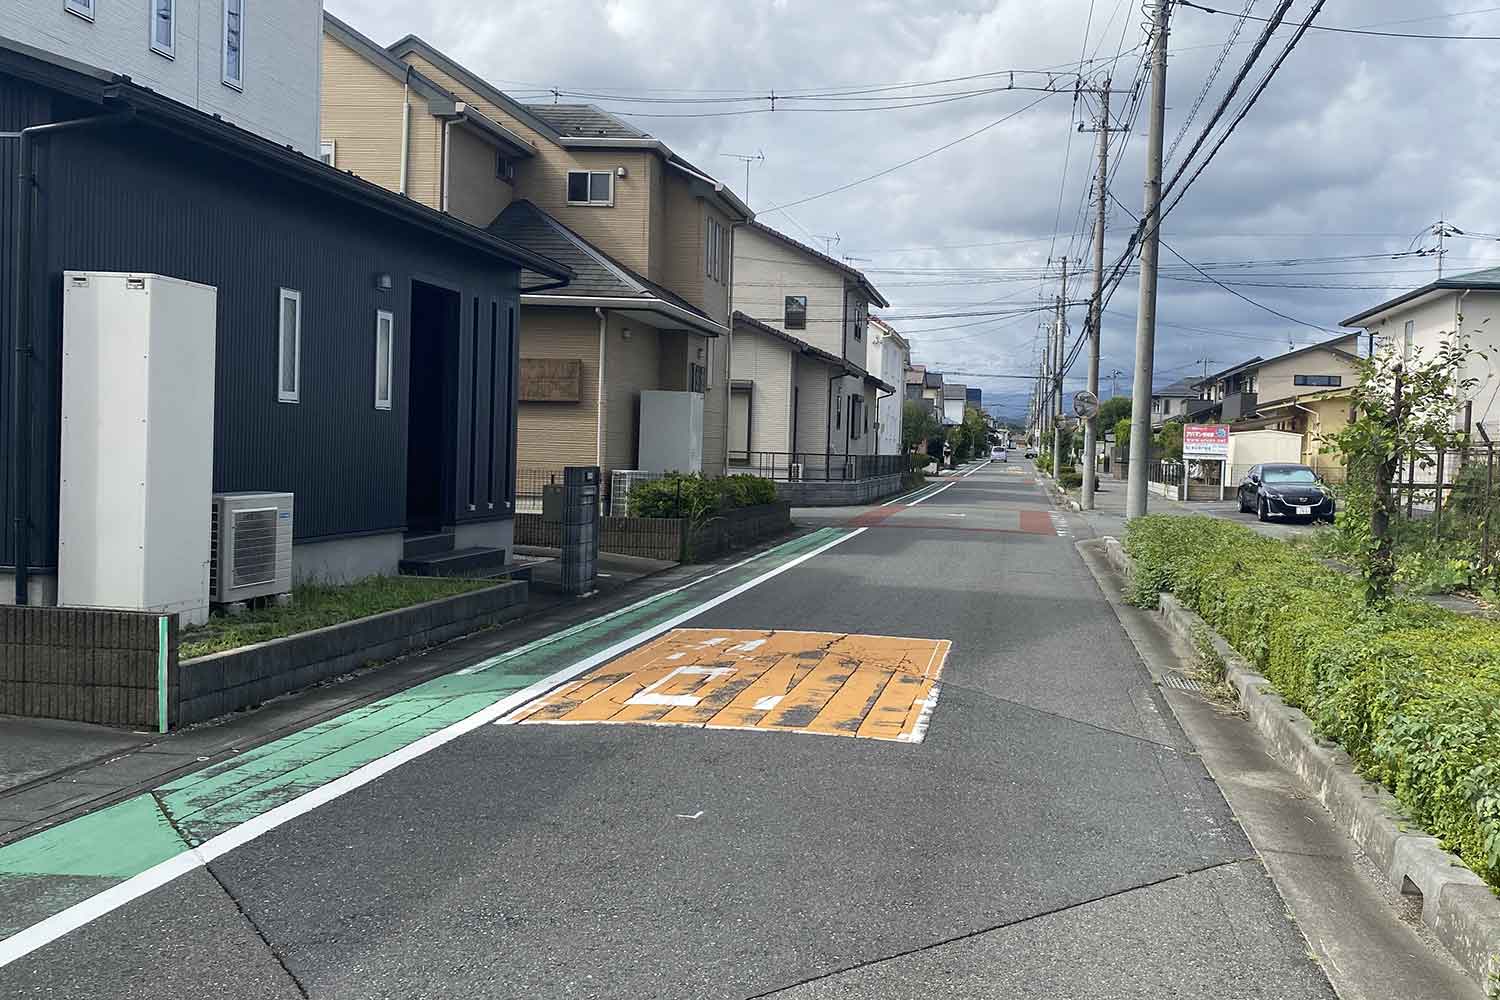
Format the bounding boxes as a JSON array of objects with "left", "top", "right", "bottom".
[{"left": 1125, "top": 0, "right": 1169, "bottom": 517}]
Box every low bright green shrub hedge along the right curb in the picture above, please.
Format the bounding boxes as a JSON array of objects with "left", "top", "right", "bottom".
[{"left": 1125, "top": 514, "right": 1500, "bottom": 888}]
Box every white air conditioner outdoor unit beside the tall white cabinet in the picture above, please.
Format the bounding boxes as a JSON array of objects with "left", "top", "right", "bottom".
[{"left": 209, "top": 493, "right": 293, "bottom": 604}]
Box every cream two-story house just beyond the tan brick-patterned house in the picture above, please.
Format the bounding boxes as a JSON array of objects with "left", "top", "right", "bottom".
[{"left": 729, "top": 222, "right": 897, "bottom": 468}]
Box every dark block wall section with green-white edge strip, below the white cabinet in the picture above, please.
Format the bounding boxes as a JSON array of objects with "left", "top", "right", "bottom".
[{"left": 0, "top": 606, "right": 177, "bottom": 729}]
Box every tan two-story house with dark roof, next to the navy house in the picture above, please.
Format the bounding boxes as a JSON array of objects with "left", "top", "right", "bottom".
[{"left": 323, "top": 15, "right": 753, "bottom": 481}]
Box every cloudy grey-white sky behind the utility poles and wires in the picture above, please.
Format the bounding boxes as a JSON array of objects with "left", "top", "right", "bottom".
[{"left": 327, "top": 0, "right": 1500, "bottom": 416}]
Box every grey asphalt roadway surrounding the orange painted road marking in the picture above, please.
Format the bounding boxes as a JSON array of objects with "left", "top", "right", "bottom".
[{"left": 0, "top": 465, "right": 1334, "bottom": 1000}]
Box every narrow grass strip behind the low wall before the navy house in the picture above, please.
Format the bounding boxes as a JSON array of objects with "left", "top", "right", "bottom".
[{"left": 177, "top": 576, "right": 495, "bottom": 660}]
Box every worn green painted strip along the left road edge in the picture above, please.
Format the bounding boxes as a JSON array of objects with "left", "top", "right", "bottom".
[{"left": 0, "top": 528, "right": 857, "bottom": 964}]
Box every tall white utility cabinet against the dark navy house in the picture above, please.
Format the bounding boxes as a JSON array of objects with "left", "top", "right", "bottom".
[{"left": 57, "top": 271, "right": 218, "bottom": 624}]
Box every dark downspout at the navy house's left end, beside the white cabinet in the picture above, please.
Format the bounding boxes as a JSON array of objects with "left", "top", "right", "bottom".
[{"left": 0, "top": 108, "right": 135, "bottom": 604}]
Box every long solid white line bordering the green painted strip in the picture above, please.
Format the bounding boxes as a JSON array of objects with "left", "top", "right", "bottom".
[{"left": 0, "top": 528, "right": 867, "bottom": 969}]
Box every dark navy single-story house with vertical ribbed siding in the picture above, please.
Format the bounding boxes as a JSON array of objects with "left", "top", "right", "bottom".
[{"left": 0, "top": 40, "right": 569, "bottom": 601}]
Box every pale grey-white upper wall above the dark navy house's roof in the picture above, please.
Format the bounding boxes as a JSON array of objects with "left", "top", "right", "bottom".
[{"left": 11, "top": 0, "right": 323, "bottom": 156}]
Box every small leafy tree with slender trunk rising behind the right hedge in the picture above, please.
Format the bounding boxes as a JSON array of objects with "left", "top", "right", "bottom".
[{"left": 1326, "top": 336, "right": 1478, "bottom": 604}]
